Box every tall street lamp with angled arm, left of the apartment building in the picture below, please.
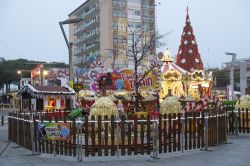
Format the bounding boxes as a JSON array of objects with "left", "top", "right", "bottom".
[{"left": 59, "top": 18, "right": 83, "bottom": 81}]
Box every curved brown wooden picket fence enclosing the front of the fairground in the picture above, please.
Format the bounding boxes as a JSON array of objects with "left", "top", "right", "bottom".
[{"left": 9, "top": 111, "right": 227, "bottom": 157}]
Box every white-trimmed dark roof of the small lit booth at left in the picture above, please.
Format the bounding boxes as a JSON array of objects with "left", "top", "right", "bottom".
[{"left": 17, "top": 84, "right": 76, "bottom": 98}]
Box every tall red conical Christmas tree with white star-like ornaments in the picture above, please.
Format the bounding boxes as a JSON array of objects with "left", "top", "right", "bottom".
[{"left": 176, "top": 8, "right": 204, "bottom": 72}]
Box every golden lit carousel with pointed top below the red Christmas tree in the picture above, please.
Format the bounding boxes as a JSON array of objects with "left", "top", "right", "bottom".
[{"left": 159, "top": 49, "right": 212, "bottom": 99}]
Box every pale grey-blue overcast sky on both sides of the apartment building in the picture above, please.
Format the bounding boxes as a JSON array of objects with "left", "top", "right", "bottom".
[{"left": 0, "top": 0, "right": 250, "bottom": 67}]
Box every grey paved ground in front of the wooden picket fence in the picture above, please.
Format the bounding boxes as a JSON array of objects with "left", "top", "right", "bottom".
[{"left": 0, "top": 109, "right": 250, "bottom": 166}]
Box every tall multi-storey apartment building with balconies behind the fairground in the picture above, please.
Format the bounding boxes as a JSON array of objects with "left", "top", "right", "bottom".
[{"left": 69, "top": 0, "right": 155, "bottom": 68}]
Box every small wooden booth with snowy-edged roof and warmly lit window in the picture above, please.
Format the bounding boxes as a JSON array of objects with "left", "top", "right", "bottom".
[{"left": 18, "top": 84, "right": 76, "bottom": 112}]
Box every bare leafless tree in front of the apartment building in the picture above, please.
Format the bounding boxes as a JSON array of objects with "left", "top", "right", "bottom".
[{"left": 127, "top": 28, "right": 164, "bottom": 112}]
